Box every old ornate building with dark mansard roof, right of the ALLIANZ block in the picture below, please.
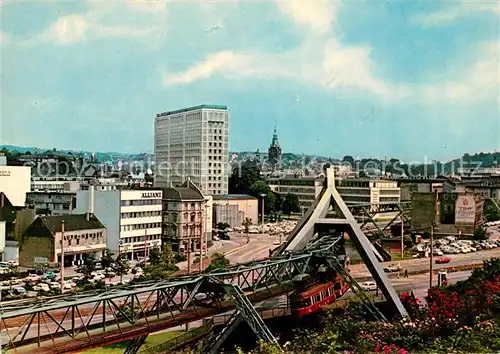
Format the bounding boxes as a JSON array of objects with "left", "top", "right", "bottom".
[{"left": 162, "top": 180, "right": 206, "bottom": 253}]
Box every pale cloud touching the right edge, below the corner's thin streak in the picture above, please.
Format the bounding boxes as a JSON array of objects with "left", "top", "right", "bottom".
[{"left": 420, "top": 41, "right": 500, "bottom": 102}]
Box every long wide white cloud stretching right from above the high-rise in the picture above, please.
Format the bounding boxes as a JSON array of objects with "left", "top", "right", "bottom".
[{"left": 164, "top": 40, "right": 409, "bottom": 98}]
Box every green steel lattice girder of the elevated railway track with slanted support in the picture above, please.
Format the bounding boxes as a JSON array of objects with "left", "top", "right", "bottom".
[{"left": 0, "top": 243, "right": 356, "bottom": 353}]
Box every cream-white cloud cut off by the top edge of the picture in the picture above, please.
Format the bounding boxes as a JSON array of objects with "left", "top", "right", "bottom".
[{"left": 276, "top": 0, "right": 340, "bottom": 33}]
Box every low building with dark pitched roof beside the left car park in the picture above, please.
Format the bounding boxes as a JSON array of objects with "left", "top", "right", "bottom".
[{"left": 19, "top": 213, "right": 106, "bottom": 267}]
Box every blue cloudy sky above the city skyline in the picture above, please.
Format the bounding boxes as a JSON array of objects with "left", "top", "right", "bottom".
[{"left": 0, "top": 0, "right": 500, "bottom": 161}]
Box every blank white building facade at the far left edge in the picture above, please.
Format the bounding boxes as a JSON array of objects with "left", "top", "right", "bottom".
[{"left": 0, "top": 165, "right": 31, "bottom": 207}]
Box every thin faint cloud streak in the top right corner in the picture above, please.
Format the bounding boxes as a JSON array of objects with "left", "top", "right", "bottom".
[{"left": 413, "top": 0, "right": 500, "bottom": 27}]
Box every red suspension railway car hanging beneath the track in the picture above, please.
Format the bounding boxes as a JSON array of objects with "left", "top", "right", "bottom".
[{"left": 290, "top": 278, "right": 349, "bottom": 318}]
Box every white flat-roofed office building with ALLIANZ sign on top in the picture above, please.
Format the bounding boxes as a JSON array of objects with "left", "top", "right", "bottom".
[{"left": 76, "top": 186, "right": 162, "bottom": 260}]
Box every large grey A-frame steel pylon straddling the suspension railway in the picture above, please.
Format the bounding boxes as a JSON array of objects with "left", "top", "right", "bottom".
[{"left": 274, "top": 168, "right": 407, "bottom": 317}]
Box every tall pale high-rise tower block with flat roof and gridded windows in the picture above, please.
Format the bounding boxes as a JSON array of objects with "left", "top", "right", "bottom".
[{"left": 155, "top": 105, "right": 229, "bottom": 195}]
